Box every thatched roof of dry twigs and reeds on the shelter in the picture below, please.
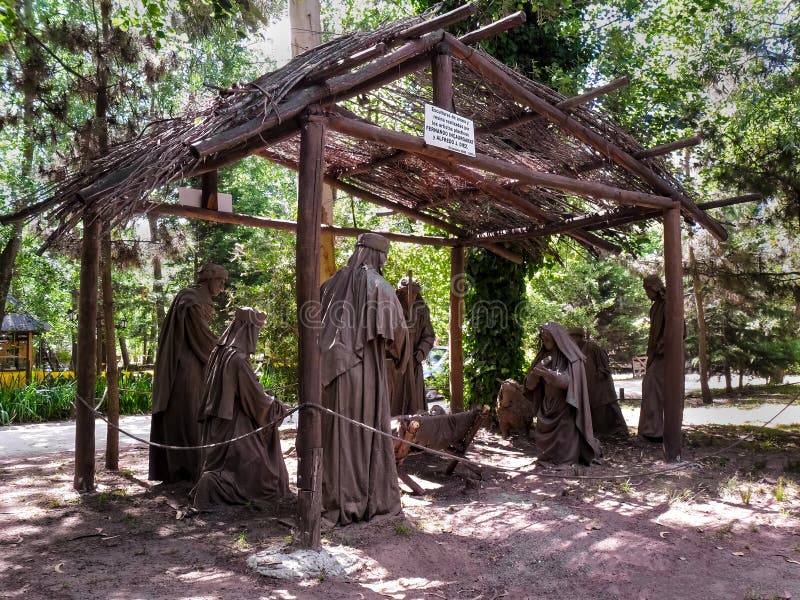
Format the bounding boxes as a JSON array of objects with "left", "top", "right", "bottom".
[{"left": 1, "top": 2, "right": 724, "bottom": 255}]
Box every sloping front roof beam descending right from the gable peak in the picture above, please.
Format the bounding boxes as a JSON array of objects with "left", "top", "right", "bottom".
[{"left": 445, "top": 33, "right": 728, "bottom": 241}]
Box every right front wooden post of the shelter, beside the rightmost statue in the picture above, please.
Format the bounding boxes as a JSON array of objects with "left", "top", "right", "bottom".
[{"left": 664, "top": 202, "right": 684, "bottom": 462}]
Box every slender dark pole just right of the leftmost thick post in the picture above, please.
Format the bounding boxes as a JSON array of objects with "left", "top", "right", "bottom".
[{"left": 100, "top": 231, "right": 119, "bottom": 471}]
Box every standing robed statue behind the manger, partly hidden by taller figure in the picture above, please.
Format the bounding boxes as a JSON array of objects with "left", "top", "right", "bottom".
[{"left": 386, "top": 276, "right": 436, "bottom": 416}]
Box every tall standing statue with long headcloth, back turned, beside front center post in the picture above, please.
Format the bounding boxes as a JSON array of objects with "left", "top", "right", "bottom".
[{"left": 319, "top": 233, "right": 410, "bottom": 525}]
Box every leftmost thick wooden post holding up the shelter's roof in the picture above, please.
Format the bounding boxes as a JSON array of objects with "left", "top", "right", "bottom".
[{"left": 73, "top": 211, "right": 100, "bottom": 492}]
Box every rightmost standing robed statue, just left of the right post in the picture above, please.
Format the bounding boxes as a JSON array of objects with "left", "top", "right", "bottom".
[{"left": 639, "top": 275, "right": 667, "bottom": 442}]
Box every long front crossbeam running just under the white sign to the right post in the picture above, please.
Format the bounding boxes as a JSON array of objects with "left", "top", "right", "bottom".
[{"left": 328, "top": 115, "right": 674, "bottom": 208}]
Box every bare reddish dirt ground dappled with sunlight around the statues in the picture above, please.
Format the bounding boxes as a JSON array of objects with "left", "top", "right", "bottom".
[{"left": 0, "top": 404, "right": 800, "bottom": 600}]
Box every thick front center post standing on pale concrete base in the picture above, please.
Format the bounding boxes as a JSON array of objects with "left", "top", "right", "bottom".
[{"left": 295, "top": 106, "right": 325, "bottom": 550}]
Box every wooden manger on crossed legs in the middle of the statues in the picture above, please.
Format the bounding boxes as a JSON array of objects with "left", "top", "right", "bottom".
[{"left": 394, "top": 404, "right": 491, "bottom": 496}]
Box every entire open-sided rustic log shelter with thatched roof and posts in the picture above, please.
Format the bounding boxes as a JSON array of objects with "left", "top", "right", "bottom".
[{"left": 0, "top": 4, "right": 726, "bottom": 547}]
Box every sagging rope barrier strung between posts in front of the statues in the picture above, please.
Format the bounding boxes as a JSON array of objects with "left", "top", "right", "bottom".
[{"left": 73, "top": 386, "right": 800, "bottom": 481}]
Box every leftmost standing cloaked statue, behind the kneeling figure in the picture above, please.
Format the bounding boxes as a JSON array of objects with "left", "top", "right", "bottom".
[{"left": 148, "top": 263, "right": 228, "bottom": 483}]
